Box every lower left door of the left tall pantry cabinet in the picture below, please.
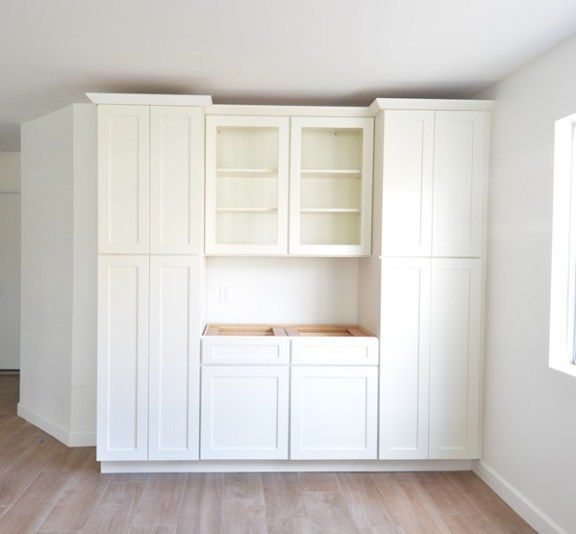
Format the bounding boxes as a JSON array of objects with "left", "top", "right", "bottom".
[{"left": 97, "top": 256, "right": 149, "bottom": 461}]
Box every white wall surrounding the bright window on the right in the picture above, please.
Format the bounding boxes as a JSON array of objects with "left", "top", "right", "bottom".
[{"left": 477, "top": 38, "right": 576, "bottom": 532}]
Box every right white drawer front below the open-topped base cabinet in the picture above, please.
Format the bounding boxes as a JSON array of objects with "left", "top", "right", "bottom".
[{"left": 292, "top": 337, "right": 378, "bottom": 365}]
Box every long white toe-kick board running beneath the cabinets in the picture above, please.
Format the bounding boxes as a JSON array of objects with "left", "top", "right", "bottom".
[{"left": 100, "top": 460, "right": 472, "bottom": 473}]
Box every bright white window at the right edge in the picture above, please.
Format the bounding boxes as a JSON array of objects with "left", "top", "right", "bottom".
[{"left": 549, "top": 114, "right": 576, "bottom": 376}]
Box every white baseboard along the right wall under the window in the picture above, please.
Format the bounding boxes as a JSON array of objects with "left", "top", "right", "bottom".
[{"left": 473, "top": 460, "right": 568, "bottom": 534}]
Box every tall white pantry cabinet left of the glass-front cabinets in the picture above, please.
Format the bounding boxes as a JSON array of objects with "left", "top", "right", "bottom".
[{"left": 98, "top": 105, "right": 204, "bottom": 460}]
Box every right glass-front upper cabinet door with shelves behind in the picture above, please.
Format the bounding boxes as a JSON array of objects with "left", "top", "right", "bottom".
[{"left": 290, "top": 117, "right": 374, "bottom": 256}]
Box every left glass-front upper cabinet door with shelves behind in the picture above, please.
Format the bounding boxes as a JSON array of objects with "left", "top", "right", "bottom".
[{"left": 206, "top": 116, "right": 289, "bottom": 255}]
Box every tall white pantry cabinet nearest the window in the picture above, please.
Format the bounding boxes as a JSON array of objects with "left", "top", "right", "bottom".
[{"left": 376, "top": 110, "right": 488, "bottom": 459}]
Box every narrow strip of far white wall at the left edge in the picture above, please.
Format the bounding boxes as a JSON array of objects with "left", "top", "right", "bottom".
[{"left": 0, "top": 152, "right": 20, "bottom": 370}]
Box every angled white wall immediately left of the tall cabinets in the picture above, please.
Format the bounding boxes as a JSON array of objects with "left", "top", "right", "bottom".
[{"left": 18, "top": 104, "right": 97, "bottom": 445}]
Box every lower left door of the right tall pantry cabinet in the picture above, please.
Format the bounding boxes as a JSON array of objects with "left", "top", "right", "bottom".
[{"left": 380, "top": 258, "right": 431, "bottom": 460}]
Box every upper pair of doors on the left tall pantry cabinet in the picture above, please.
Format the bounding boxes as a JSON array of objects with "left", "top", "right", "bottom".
[{"left": 98, "top": 105, "right": 204, "bottom": 254}]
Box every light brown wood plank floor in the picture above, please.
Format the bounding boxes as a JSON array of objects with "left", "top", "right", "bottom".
[{"left": 0, "top": 376, "right": 533, "bottom": 534}]
